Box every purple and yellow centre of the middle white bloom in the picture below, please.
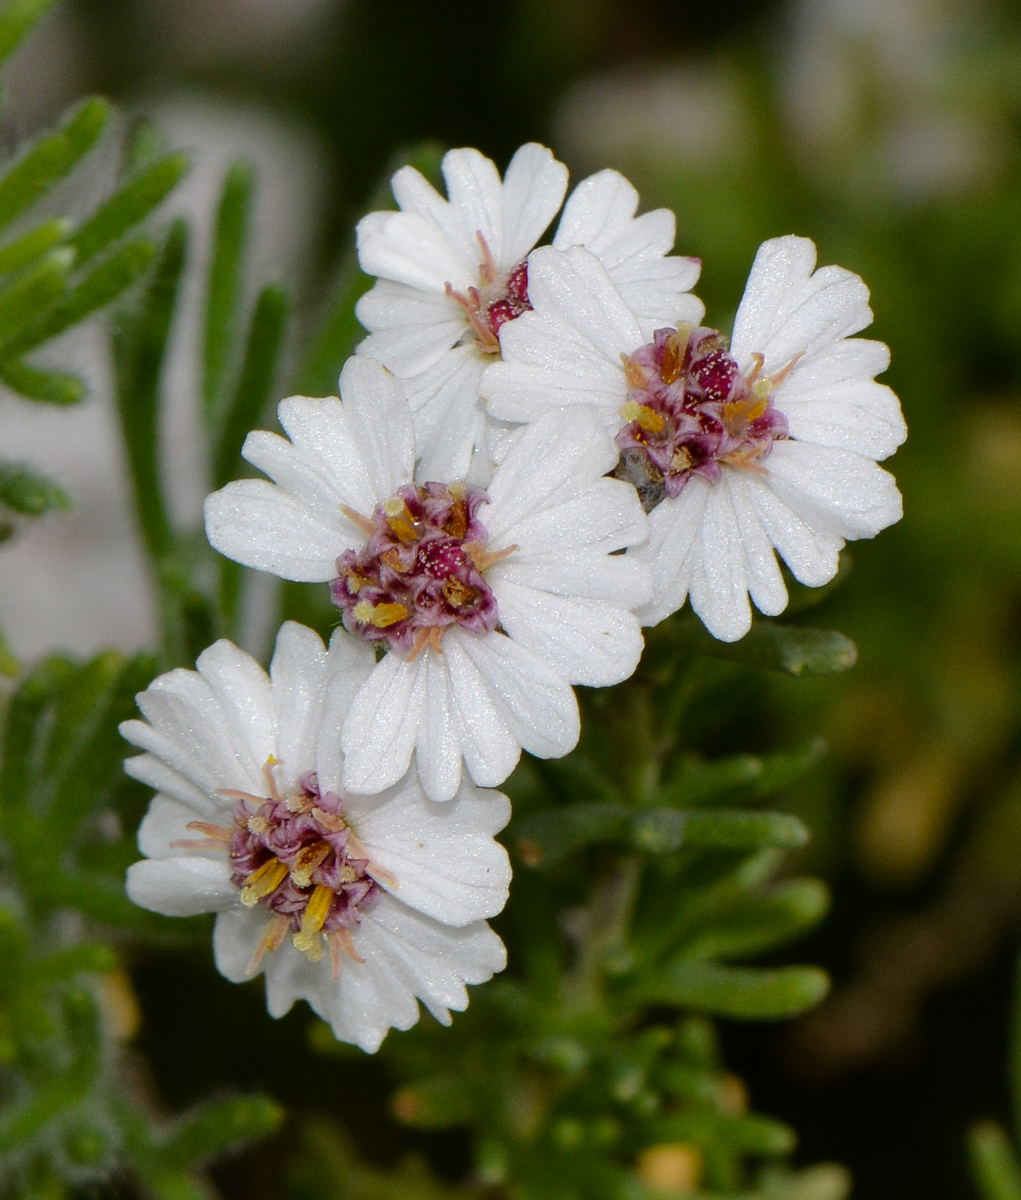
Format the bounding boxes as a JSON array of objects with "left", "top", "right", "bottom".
[{"left": 330, "top": 484, "right": 509, "bottom": 656}]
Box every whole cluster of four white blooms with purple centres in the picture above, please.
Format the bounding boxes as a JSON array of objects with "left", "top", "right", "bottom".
[{"left": 122, "top": 145, "right": 905, "bottom": 1050}]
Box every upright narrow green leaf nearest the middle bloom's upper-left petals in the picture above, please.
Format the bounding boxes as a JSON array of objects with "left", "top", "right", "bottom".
[{"left": 212, "top": 286, "right": 287, "bottom": 487}]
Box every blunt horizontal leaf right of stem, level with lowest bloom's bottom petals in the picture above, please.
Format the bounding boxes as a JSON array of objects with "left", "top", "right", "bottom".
[{"left": 629, "top": 960, "right": 829, "bottom": 1021}]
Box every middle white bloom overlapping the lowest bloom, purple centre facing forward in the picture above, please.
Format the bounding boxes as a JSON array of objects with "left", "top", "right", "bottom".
[{"left": 205, "top": 355, "right": 650, "bottom": 800}]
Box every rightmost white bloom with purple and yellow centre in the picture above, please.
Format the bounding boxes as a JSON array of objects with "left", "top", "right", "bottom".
[{"left": 482, "top": 236, "right": 906, "bottom": 642}]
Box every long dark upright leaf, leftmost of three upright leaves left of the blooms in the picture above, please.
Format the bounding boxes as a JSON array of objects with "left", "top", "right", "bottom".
[{"left": 114, "top": 220, "right": 188, "bottom": 562}]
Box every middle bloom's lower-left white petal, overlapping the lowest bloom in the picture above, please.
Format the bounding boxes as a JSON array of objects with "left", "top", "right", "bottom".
[{"left": 341, "top": 654, "right": 426, "bottom": 794}]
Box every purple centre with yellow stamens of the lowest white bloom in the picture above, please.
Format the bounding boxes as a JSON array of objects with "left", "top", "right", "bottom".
[{"left": 227, "top": 767, "right": 385, "bottom": 959}]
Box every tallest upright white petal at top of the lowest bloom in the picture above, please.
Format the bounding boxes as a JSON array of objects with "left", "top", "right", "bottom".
[{"left": 270, "top": 620, "right": 326, "bottom": 790}]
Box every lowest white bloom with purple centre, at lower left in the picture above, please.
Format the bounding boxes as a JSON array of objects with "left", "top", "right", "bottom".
[{"left": 121, "top": 622, "right": 510, "bottom": 1052}]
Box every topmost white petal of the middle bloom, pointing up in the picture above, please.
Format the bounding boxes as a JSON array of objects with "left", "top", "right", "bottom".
[{"left": 341, "top": 354, "right": 415, "bottom": 504}]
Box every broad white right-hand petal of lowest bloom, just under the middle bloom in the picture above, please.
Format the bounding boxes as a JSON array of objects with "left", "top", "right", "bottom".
[{"left": 344, "top": 777, "right": 511, "bottom": 925}]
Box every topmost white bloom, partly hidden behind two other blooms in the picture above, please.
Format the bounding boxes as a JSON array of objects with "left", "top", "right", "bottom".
[{"left": 356, "top": 143, "right": 703, "bottom": 485}]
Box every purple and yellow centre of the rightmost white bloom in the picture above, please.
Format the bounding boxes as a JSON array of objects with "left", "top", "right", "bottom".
[{"left": 617, "top": 325, "right": 789, "bottom": 508}]
